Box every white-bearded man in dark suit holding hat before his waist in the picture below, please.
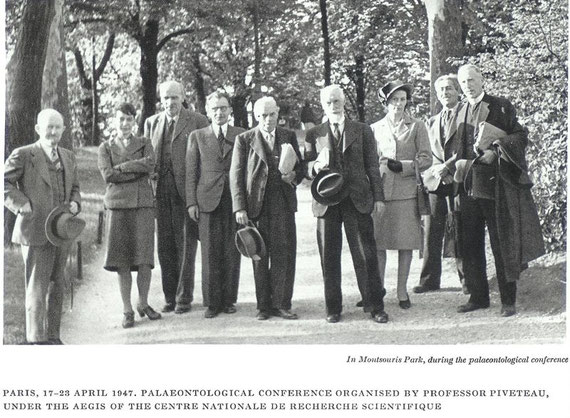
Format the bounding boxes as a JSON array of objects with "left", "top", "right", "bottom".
[{"left": 305, "top": 85, "right": 388, "bottom": 323}]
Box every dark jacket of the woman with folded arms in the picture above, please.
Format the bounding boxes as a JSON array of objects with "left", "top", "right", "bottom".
[{"left": 97, "top": 136, "right": 155, "bottom": 209}]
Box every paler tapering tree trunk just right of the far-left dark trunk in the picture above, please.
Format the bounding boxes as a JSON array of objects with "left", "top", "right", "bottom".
[{"left": 42, "top": 0, "right": 73, "bottom": 149}]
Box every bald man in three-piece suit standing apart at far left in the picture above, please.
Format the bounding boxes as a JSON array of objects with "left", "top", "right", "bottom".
[{"left": 4, "top": 109, "right": 81, "bottom": 344}]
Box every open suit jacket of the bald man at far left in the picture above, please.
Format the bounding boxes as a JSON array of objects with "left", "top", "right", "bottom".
[{"left": 4, "top": 141, "right": 81, "bottom": 245}]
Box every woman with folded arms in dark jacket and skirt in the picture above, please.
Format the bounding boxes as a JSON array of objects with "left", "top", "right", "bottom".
[{"left": 98, "top": 103, "right": 161, "bottom": 328}]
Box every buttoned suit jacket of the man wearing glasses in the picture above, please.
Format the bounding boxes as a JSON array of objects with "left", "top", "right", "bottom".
[{"left": 186, "top": 125, "right": 245, "bottom": 212}]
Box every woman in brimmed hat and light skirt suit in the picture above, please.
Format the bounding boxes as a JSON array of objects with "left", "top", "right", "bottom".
[{"left": 371, "top": 81, "right": 432, "bottom": 309}]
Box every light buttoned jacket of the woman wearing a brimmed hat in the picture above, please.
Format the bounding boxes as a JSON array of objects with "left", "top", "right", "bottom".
[{"left": 371, "top": 114, "right": 432, "bottom": 200}]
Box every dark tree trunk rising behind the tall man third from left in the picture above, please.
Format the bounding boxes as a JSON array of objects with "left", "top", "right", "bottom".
[{"left": 135, "top": 19, "right": 159, "bottom": 135}]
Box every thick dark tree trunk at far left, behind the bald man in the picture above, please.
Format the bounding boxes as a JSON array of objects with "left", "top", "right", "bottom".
[{"left": 4, "top": 0, "right": 55, "bottom": 246}]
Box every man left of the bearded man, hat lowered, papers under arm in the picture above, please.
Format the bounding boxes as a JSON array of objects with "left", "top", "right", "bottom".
[{"left": 230, "top": 97, "right": 304, "bottom": 320}]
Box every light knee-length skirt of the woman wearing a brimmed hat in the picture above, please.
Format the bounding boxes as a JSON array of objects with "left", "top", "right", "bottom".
[{"left": 372, "top": 198, "right": 422, "bottom": 250}]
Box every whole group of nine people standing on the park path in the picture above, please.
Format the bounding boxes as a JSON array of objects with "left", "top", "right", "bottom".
[{"left": 5, "top": 64, "right": 544, "bottom": 343}]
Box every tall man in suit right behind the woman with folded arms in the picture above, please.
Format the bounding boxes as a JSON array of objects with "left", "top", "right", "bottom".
[{"left": 144, "top": 81, "right": 209, "bottom": 314}]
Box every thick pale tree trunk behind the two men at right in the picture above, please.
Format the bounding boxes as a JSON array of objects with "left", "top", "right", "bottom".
[{"left": 425, "top": 0, "right": 464, "bottom": 115}]
